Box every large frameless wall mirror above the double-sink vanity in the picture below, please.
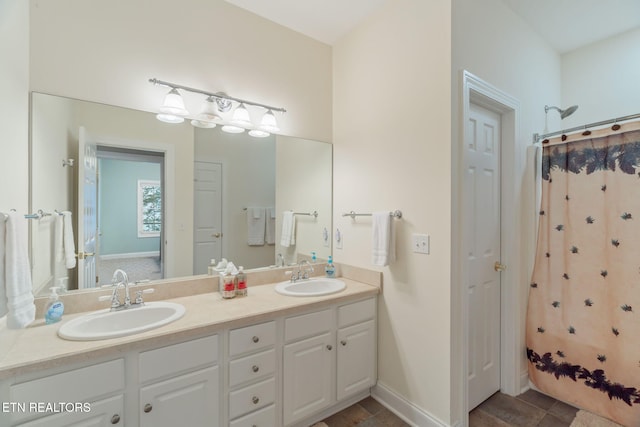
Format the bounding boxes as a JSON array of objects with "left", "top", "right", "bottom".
[{"left": 30, "top": 92, "right": 332, "bottom": 295}]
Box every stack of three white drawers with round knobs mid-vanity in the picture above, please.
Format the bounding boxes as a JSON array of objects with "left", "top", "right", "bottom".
[{"left": 228, "top": 321, "right": 278, "bottom": 427}]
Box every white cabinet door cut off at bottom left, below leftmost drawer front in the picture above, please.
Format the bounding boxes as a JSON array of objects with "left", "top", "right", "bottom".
[{"left": 19, "top": 395, "right": 125, "bottom": 427}]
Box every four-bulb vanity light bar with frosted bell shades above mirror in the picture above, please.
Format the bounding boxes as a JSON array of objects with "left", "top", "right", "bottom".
[{"left": 149, "top": 79, "right": 287, "bottom": 138}]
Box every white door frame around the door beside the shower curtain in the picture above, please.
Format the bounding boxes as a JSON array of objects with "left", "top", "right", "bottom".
[{"left": 452, "top": 70, "right": 523, "bottom": 426}]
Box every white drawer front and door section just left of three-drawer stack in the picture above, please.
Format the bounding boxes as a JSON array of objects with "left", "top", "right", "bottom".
[{"left": 138, "top": 335, "right": 222, "bottom": 427}]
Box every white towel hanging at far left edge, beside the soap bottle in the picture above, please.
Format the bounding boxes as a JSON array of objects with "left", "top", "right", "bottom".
[{"left": 0, "top": 212, "right": 36, "bottom": 329}]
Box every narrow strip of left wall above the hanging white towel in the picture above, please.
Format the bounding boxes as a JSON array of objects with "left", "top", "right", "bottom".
[{"left": 0, "top": 0, "right": 29, "bottom": 213}]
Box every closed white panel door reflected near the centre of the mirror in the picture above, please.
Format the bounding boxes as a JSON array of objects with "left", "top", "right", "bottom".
[{"left": 193, "top": 162, "right": 222, "bottom": 274}]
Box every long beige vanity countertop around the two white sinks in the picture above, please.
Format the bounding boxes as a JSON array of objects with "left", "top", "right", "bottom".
[{"left": 0, "top": 277, "right": 380, "bottom": 379}]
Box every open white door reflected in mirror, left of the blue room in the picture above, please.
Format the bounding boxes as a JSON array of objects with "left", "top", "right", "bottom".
[{"left": 77, "top": 127, "right": 98, "bottom": 289}]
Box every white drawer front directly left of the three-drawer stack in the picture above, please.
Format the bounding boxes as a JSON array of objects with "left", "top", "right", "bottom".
[{"left": 138, "top": 335, "right": 218, "bottom": 382}]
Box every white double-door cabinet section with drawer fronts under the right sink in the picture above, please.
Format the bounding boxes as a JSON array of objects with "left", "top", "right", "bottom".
[{"left": 283, "top": 298, "right": 377, "bottom": 425}]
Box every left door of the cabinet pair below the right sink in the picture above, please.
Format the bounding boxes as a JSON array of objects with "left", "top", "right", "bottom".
[{"left": 283, "top": 333, "right": 336, "bottom": 425}]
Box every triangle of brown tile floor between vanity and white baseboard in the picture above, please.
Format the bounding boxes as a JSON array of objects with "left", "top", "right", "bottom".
[{"left": 323, "top": 397, "right": 409, "bottom": 427}]
